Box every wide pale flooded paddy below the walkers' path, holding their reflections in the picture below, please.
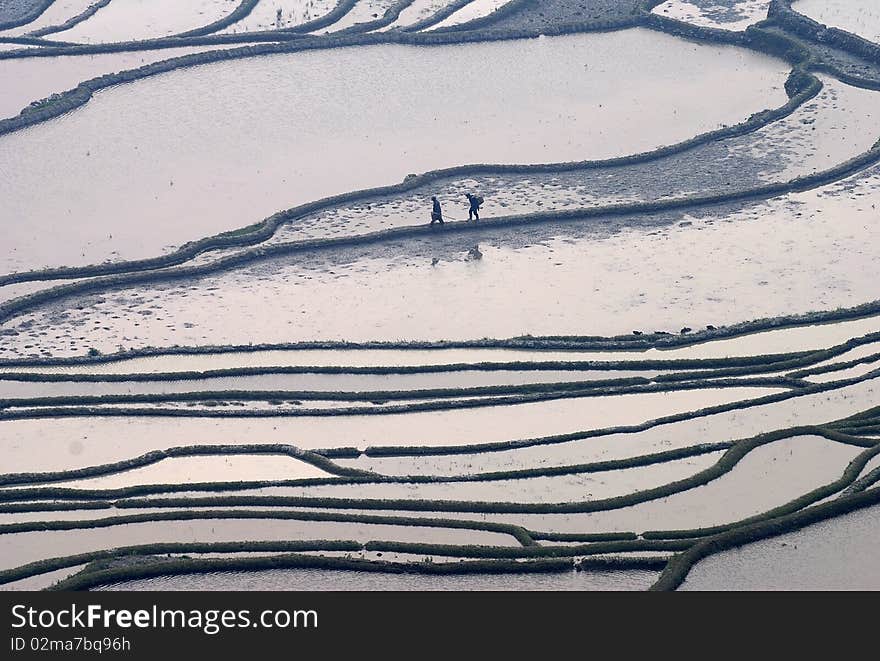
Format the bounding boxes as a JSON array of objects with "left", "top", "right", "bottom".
[{"left": 8, "top": 167, "right": 880, "bottom": 355}]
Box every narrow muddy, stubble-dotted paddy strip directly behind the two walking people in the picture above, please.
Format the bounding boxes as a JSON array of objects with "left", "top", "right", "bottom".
[{"left": 237, "top": 76, "right": 880, "bottom": 248}]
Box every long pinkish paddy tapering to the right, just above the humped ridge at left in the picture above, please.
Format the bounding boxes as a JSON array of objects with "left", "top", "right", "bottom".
[{"left": 0, "top": 388, "right": 779, "bottom": 472}]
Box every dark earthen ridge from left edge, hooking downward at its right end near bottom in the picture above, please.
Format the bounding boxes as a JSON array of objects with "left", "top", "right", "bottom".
[{"left": 0, "top": 508, "right": 537, "bottom": 546}]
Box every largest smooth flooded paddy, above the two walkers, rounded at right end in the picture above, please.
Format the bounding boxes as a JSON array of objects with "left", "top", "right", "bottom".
[{"left": 0, "top": 30, "right": 787, "bottom": 270}]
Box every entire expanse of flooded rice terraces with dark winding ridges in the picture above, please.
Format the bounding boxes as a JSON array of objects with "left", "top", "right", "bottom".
[{"left": 0, "top": 0, "right": 880, "bottom": 591}]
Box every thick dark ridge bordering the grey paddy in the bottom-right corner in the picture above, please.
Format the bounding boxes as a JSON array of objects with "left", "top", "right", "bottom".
[{"left": 650, "top": 480, "right": 880, "bottom": 591}]
